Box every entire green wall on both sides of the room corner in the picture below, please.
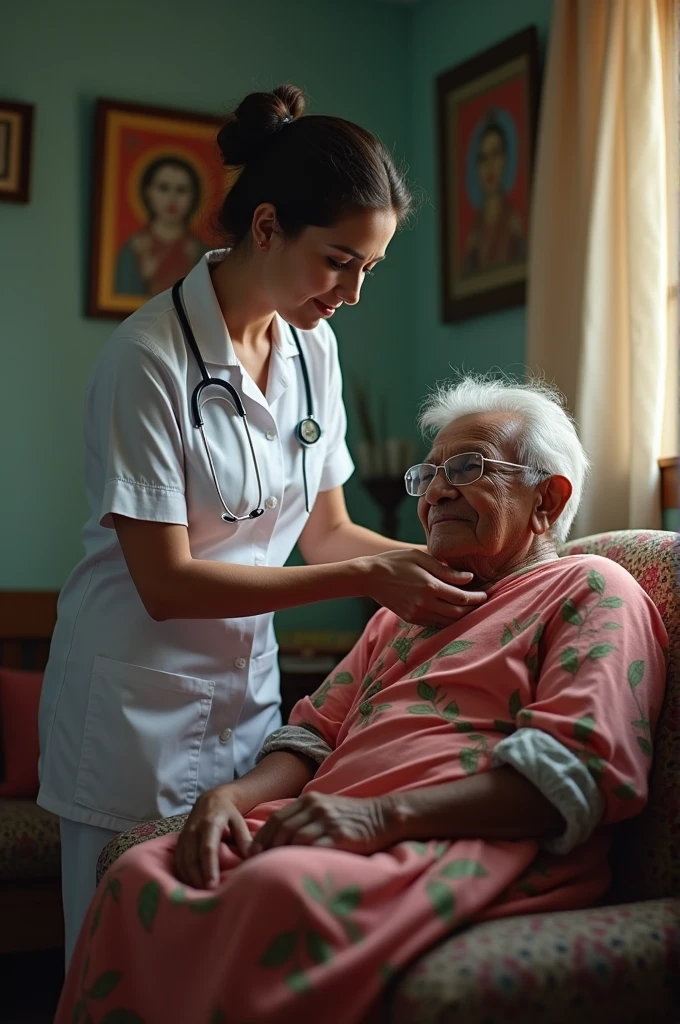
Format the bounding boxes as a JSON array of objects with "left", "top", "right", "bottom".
[{"left": 0, "top": 0, "right": 552, "bottom": 629}]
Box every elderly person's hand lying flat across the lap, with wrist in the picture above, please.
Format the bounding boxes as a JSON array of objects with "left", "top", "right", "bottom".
[{"left": 250, "top": 793, "right": 397, "bottom": 857}]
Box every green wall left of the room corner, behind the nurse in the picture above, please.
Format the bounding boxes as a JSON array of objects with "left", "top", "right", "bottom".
[{"left": 0, "top": 0, "right": 410, "bottom": 630}]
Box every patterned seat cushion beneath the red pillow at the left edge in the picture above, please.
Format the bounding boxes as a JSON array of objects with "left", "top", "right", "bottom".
[{"left": 0, "top": 800, "right": 61, "bottom": 882}]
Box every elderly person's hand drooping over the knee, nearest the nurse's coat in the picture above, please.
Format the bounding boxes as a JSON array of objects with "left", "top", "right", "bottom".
[{"left": 175, "top": 784, "right": 252, "bottom": 889}]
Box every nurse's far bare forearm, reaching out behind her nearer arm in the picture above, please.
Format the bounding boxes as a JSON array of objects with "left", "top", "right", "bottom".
[{"left": 298, "top": 486, "right": 427, "bottom": 565}]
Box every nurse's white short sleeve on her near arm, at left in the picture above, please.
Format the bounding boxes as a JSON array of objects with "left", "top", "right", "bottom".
[{"left": 93, "top": 338, "right": 187, "bottom": 527}]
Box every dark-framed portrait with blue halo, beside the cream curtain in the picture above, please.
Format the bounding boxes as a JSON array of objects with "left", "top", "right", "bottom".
[{"left": 437, "top": 28, "right": 539, "bottom": 322}]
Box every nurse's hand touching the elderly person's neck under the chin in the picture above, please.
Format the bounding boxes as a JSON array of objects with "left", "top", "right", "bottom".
[{"left": 368, "top": 548, "right": 486, "bottom": 626}]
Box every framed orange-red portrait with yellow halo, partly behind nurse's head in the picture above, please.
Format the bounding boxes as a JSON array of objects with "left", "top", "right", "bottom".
[{"left": 87, "top": 99, "right": 226, "bottom": 319}]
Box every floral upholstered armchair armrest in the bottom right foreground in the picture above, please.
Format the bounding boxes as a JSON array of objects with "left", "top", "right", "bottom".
[{"left": 389, "top": 900, "right": 680, "bottom": 1024}]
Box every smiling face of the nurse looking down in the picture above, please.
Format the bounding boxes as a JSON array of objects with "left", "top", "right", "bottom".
[{"left": 265, "top": 210, "right": 396, "bottom": 331}]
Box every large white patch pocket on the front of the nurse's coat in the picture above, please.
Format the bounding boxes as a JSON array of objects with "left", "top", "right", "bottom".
[{"left": 75, "top": 656, "right": 215, "bottom": 821}]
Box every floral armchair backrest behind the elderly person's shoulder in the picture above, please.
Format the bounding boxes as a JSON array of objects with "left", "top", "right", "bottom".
[{"left": 560, "top": 529, "right": 680, "bottom": 900}]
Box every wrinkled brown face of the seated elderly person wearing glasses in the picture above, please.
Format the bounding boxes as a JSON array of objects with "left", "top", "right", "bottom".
[{"left": 418, "top": 413, "right": 540, "bottom": 571}]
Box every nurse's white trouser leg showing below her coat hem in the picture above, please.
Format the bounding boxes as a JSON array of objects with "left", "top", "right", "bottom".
[{"left": 59, "top": 818, "right": 118, "bottom": 970}]
